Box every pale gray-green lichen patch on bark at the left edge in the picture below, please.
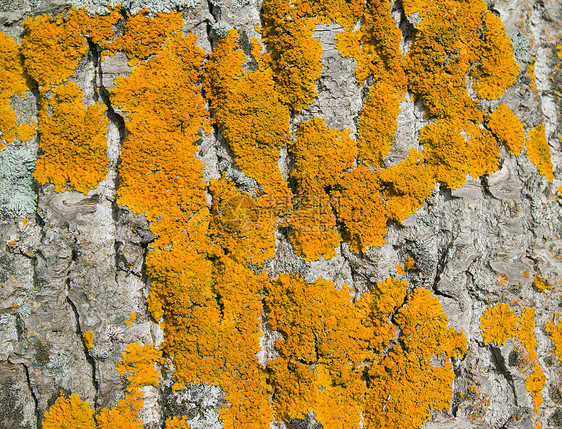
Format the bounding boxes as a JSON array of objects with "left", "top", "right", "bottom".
[{"left": 0, "top": 143, "right": 37, "bottom": 217}]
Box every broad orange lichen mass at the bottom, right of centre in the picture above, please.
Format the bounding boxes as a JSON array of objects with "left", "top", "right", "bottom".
[{"left": 266, "top": 275, "right": 466, "bottom": 429}]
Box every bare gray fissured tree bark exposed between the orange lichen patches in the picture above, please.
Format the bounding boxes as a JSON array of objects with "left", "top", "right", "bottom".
[{"left": 0, "top": 0, "right": 562, "bottom": 429}]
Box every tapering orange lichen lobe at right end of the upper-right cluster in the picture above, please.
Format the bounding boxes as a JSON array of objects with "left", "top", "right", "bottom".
[{"left": 470, "top": 12, "right": 519, "bottom": 99}]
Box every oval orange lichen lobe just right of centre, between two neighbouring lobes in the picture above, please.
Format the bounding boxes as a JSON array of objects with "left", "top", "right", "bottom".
[{"left": 331, "top": 165, "right": 386, "bottom": 252}]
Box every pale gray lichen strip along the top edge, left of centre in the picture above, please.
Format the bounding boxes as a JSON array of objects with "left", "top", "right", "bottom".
[{"left": 68, "top": 0, "right": 199, "bottom": 15}]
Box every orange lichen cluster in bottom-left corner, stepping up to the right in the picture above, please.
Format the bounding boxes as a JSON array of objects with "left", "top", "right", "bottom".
[{"left": 43, "top": 344, "right": 160, "bottom": 429}]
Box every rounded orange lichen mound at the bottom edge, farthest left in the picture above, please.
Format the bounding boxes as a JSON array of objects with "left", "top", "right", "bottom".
[{"left": 43, "top": 392, "right": 96, "bottom": 429}]
